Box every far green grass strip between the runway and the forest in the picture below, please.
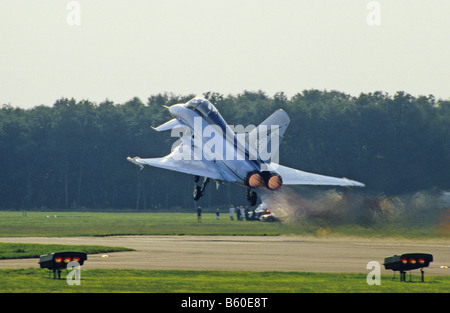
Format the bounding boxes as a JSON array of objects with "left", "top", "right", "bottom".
[{"left": 0, "top": 211, "right": 450, "bottom": 238}]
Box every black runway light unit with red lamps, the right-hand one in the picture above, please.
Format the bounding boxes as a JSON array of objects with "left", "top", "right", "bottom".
[{"left": 384, "top": 253, "right": 433, "bottom": 282}]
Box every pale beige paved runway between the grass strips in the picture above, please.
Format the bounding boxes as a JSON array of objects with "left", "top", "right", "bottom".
[{"left": 0, "top": 236, "right": 450, "bottom": 275}]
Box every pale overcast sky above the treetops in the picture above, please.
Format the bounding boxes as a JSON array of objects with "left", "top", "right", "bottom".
[{"left": 0, "top": 0, "right": 450, "bottom": 108}]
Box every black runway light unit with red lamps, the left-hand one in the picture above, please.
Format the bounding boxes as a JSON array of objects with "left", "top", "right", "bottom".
[{"left": 39, "top": 251, "right": 87, "bottom": 279}]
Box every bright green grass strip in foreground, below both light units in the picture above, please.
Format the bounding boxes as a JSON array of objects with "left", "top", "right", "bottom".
[{"left": 0, "top": 269, "right": 450, "bottom": 293}]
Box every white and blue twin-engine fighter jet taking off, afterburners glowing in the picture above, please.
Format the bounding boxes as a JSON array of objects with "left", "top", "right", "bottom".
[{"left": 127, "top": 97, "right": 364, "bottom": 206}]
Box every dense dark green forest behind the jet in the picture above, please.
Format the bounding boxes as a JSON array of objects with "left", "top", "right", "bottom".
[{"left": 0, "top": 90, "right": 450, "bottom": 210}]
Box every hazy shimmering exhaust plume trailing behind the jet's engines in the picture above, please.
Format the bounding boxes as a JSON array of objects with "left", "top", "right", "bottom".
[{"left": 261, "top": 187, "right": 450, "bottom": 234}]
